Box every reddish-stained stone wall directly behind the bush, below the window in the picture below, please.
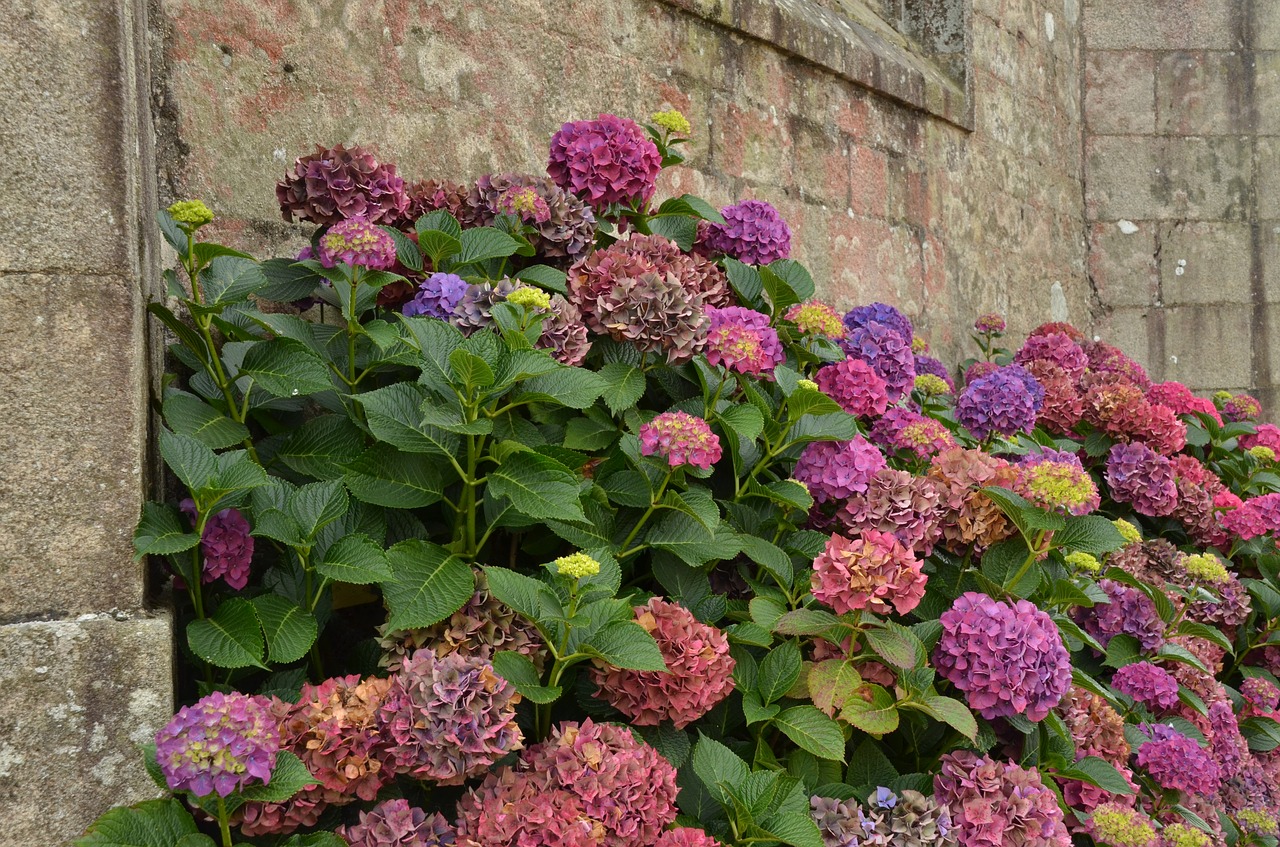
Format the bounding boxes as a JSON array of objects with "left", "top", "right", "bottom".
[{"left": 149, "top": 0, "right": 1089, "bottom": 358}]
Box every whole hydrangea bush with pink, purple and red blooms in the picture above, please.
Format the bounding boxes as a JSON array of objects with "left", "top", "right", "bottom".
[{"left": 78, "top": 111, "right": 1280, "bottom": 847}]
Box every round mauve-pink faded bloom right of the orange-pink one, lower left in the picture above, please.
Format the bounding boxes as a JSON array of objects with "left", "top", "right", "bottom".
[{"left": 379, "top": 649, "right": 524, "bottom": 786}]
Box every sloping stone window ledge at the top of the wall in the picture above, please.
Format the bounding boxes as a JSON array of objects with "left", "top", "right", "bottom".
[{"left": 660, "top": 0, "right": 974, "bottom": 131}]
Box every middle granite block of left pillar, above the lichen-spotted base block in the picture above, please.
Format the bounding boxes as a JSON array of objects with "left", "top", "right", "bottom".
[{"left": 0, "top": 274, "right": 147, "bottom": 621}]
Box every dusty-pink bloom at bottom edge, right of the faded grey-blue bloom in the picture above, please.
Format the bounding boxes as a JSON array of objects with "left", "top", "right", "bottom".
[{"left": 933, "top": 750, "right": 1071, "bottom": 847}]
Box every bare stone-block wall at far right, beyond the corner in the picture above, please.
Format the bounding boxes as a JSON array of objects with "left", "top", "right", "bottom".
[{"left": 1084, "top": 0, "right": 1280, "bottom": 412}]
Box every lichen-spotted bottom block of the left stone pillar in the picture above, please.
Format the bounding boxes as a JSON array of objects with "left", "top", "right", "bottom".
[{"left": 0, "top": 615, "right": 173, "bottom": 847}]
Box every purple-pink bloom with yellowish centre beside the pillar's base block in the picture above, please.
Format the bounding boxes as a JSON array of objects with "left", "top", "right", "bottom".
[{"left": 156, "top": 691, "right": 280, "bottom": 797}]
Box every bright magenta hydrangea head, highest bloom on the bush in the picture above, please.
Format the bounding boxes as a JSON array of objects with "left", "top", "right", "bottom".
[{"left": 547, "top": 114, "right": 662, "bottom": 211}]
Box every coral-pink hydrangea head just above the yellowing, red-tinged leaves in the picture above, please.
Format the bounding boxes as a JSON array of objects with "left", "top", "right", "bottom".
[{"left": 810, "top": 530, "right": 928, "bottom": 614}]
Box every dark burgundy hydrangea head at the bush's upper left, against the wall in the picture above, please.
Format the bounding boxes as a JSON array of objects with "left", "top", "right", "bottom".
[{"left": 275, "top": 145, "right": 408, "bottom": 225}]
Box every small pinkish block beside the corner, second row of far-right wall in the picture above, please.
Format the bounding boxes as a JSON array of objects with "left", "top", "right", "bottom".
[{"left": 1084, "top": 50, "right": 1156, "bottom": 136}]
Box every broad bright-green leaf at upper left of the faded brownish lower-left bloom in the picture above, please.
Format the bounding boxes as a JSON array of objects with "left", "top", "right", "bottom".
[{"left": 383, "top": 539, "right": 475, "bottom": 629}]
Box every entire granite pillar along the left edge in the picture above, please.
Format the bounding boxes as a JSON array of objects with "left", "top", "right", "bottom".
[{"left": 0, "top": 0, "right": 173, "bottom": 847}]
